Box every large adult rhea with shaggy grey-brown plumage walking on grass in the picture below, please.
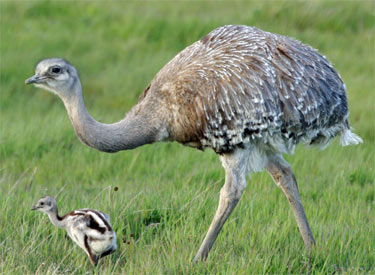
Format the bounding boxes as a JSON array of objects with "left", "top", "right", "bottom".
[{"left": 26, "top": 25, "right": 361, "bottom": 261}]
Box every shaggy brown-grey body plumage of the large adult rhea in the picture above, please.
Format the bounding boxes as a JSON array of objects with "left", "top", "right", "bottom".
[{"left": 141, "top": 26, "right": 356, "bottom": 153}]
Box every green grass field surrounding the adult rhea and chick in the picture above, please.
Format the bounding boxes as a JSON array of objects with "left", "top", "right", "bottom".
[{"left": 0, "top": 1, "right": 375, "bottom": 274}]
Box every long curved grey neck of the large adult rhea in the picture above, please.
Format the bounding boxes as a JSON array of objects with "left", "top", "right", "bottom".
[{"left": 62, "top": 81, "right": 160, "bottom": 153}]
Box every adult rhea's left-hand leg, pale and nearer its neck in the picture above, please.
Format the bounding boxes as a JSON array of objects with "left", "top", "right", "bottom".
[{"left": 194, "top": 150, "right": 247, "bottom": 262}]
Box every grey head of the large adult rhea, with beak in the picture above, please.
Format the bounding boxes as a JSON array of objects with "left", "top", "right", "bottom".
[{"left": 25, "top": 58, "right": 81, "bottom": 99}]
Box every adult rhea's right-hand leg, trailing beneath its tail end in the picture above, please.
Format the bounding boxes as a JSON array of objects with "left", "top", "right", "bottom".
[{"left": 266, "top": 155, "right": 315, "bottom": 249}]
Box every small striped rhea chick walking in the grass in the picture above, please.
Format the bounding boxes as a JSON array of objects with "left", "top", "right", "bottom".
[{"left": 31, "top": 196, "right": 117, "bottom": 266}]
